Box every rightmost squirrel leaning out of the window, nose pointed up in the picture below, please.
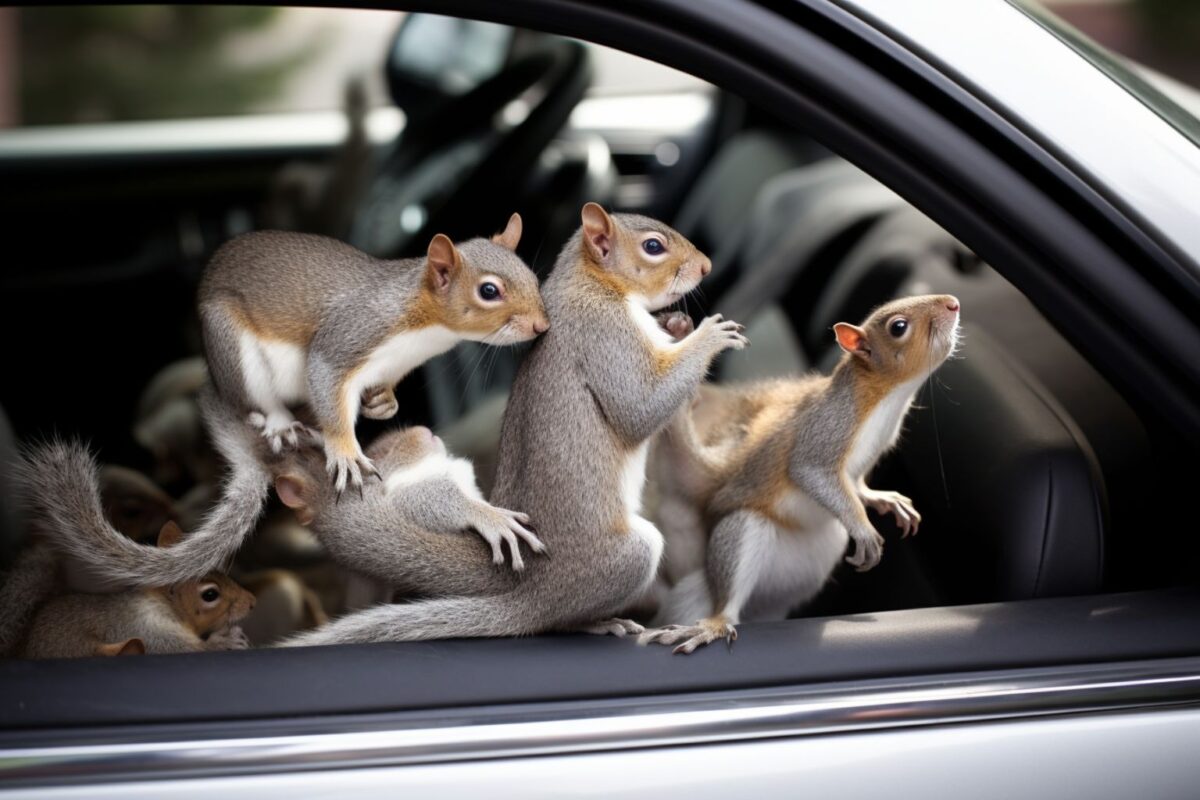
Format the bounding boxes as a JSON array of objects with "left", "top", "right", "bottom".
[{"left": 641, "top": 295, "right": 960, "bottom": 654}]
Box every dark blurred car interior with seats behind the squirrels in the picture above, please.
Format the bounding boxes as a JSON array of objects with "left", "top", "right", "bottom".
[{"left": 0, "top": 9, "right": 1200, "bottom": 714}]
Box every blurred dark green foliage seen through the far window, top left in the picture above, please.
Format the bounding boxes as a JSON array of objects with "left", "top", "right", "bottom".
[{"left": 18, "top": 6, "right": 324, "bottom": 125}]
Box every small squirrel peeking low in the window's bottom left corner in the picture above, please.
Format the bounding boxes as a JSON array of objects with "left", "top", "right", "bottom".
[{"left": 23, "top": 522, "right": 254, "bottom": 658}]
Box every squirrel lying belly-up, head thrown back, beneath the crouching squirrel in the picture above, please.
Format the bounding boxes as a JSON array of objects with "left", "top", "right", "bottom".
[{"left": 268, "top": 427, "right": 545, "bottom": 604}]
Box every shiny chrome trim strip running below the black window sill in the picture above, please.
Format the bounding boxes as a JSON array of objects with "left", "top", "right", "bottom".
[{"left": 0, "top": 657, "right": 1200, "bottom": 789}]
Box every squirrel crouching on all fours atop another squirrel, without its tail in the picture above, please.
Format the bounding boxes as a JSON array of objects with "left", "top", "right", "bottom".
[{"left": 199, "top": 219, "right": 548, "bottom": 492}]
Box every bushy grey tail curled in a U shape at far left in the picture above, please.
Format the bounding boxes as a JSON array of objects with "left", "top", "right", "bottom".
[{"left": 14, "top": 386, "right": 271, "bottom": 587}]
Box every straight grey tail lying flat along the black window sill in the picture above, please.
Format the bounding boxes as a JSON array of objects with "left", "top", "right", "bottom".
[{"left": 278, "top": 594, "right": 539, "bottom": 648}]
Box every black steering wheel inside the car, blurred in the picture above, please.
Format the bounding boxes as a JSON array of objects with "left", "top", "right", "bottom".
[{"left": 349, "top": 40, "right": 590, "bottom": 258}]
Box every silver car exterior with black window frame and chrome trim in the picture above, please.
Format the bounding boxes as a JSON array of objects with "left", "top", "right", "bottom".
[{"left": 0, "top": 0, "right": 1200, "bottom": 796}]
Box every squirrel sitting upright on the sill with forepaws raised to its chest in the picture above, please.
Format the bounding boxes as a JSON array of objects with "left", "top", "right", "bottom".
[{"left": 283, "top": 203, "right": 746, "bottom": 644}]
